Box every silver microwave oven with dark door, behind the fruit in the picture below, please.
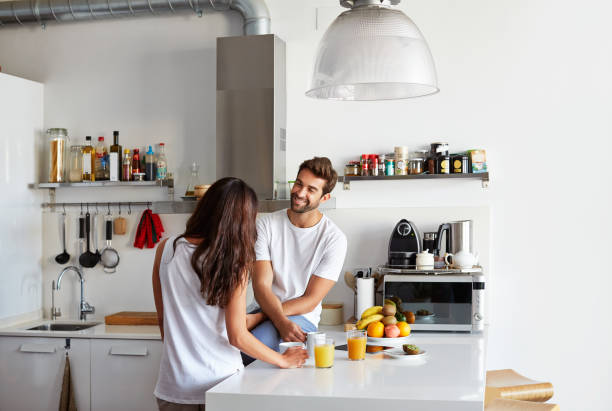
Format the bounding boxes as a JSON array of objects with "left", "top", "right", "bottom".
[{"left": 383, "top": 272, "right": 485, "bottom": 332}]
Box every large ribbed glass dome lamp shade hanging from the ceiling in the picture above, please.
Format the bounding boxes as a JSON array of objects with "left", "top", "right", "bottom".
[{"left": 306, "top": 5, "right": 438, "bottom": 100}]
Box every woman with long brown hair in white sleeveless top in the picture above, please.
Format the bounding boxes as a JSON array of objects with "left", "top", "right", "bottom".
[{"left": 153, "top": 178, "right": 307, "bottom": 410}]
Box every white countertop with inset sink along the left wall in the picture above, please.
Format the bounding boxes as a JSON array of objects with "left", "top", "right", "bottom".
[{"left": 0, "top": 319, "right": 161, "bottom": 340}]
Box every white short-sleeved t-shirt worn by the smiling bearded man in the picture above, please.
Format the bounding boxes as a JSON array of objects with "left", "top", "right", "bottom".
[{"left": 255, "top": 210, "right": 347, "bottom": 327}]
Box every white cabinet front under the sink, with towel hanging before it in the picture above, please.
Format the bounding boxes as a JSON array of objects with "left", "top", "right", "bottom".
[{"left": 0, "top": 337, "right": 90, "bottom": 411}]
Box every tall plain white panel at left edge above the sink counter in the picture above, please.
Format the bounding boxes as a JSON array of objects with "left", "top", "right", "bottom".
[{"left": 0, "top": 73, "right": 43, "bottom": 325}]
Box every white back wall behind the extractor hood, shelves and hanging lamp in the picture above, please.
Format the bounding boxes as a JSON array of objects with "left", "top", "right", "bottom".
[{"left": 0, "top": 0, "right": 612, "bottom": 410}]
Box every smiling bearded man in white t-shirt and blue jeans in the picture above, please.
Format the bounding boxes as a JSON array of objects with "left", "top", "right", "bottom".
[{"left": 243, "top": 157, "right": 347, "bottom": 364}]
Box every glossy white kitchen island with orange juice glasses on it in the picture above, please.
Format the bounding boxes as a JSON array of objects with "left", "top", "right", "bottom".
[{"left": 206, "top": 327, "right": 486, "bottom": 411}]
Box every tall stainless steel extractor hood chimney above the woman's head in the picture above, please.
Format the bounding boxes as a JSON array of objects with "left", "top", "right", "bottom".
[{"left": 217, "top": 34, "right": 288, "bottom": 200}]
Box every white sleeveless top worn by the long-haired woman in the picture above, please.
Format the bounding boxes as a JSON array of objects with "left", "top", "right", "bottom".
[{"left": 154, "top": 237, "right": 244, "bottom": 404}]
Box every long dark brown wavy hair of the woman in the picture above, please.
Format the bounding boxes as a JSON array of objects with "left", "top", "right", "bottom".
[{"left": 173, "top": 177, "right": 257, "bottom": 308}]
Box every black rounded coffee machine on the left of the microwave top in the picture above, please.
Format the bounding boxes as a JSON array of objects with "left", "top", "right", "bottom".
[{"left": 388, "top": 219, "right": 423, "bottom": 268}]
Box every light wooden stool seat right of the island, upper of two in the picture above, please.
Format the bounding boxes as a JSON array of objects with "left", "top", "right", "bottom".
[{"left": 485, "top": 370, "right": 553, "bottom": 409}]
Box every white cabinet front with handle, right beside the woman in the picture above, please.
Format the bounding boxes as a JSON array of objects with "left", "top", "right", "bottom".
[{"left": 91, "top": 339, "right": 162, "bottom": 411}]
